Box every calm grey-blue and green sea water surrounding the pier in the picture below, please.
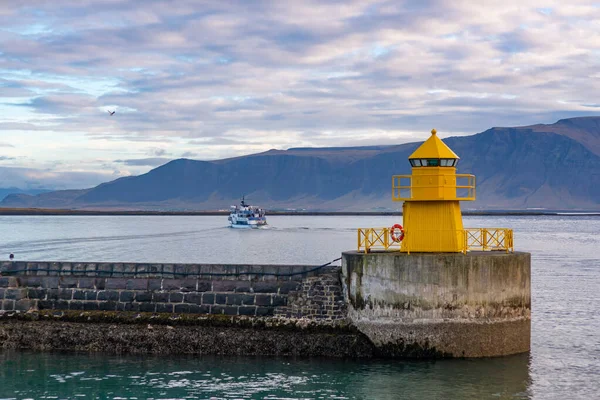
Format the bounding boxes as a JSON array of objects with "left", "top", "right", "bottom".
[{"left": 0, "top": 216, "right": 600, "bottom": 399}]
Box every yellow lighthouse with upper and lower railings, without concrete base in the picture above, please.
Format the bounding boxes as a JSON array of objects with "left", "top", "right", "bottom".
[{"left": 358, "top": 129, "right": 513, "bottom": 254}]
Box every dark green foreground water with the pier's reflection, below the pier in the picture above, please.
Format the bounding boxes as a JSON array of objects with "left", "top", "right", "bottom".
[{"left": 0, "top": 352, "right": 529, "bottom": 400}]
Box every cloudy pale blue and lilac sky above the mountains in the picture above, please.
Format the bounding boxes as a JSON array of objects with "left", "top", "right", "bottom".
[{"left": 0, "top": 0, "right": 600, "bottom": 188}]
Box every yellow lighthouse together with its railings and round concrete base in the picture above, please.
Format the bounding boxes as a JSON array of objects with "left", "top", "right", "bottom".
[{"left": 352, "top": 130, "right": 531, "bottom": 357}]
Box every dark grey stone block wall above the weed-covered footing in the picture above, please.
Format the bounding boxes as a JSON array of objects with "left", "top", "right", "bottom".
[{"left": 0, "top": 262, "right": 345, "bottom": 319}]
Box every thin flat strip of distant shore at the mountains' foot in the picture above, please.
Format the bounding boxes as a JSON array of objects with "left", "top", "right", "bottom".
[{"left": 0, "top": 208, "right": 600, "bottom": 217}]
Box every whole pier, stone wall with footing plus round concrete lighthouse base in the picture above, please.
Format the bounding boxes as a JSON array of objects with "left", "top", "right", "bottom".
[{"left": 0, "top": 252, "right": 531, "bottom": 358}]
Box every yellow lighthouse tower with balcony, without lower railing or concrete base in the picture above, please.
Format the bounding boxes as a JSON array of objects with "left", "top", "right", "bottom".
[{"left": 392, "top": 129, "right": 475, "bottom": 252}]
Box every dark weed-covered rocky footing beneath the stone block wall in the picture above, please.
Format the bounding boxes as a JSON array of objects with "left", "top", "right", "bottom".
[{"left": 0, "top": 310, "right": 376, "bottom": 359}]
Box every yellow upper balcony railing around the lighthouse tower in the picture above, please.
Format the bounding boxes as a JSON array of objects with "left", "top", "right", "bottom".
[{"left": 392, "top": 174, "right": 475, "bottom": 201}]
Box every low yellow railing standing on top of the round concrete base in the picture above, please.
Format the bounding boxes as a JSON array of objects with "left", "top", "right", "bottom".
[{"left": 358, "top": 228, "right": 514, "bottom": 254}]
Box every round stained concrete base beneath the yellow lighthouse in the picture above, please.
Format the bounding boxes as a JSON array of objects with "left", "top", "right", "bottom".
[{"left": 342, "top": 252, "right": 531, "bottom": 358}]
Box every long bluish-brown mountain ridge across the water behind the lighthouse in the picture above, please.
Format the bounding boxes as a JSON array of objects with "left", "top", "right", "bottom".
[{"left": 0, "top": 117, "right": 600, "bottom": 210}]
